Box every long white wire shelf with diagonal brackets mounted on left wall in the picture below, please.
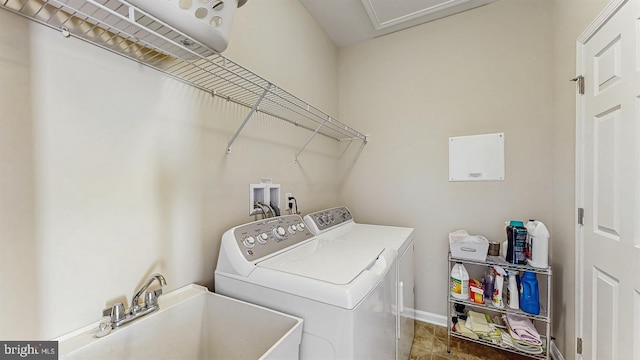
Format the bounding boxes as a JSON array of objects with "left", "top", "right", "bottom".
[{"left": 0, "top": 0, "right": 368, "bottom": 161}]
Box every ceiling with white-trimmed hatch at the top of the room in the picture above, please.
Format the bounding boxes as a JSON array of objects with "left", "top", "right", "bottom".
[{"left": 298, "top": 0, "right": 496, "bottom": 47}]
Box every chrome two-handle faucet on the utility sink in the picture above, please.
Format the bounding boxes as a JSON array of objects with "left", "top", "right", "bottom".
[{"left": 100, "top": 273, "right": 167, "bottom": 335}]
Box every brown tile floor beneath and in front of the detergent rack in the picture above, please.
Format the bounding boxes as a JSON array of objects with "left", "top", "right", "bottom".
[{"left": 410, "top": 321, "right": 531, "bottom": 360}]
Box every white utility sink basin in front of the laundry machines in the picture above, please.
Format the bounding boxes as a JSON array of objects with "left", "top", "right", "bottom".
[{"left": 55, "top": 285, "right": 302, "bottom": 360}]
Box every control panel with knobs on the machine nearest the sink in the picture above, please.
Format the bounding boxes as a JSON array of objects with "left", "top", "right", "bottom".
[{"left": 233, "top": 215, "right": 313, "bottom": 262}]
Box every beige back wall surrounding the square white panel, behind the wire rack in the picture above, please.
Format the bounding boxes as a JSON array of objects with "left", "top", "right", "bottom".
[{"left": 339, "top": 0, "right": 553, "bottom": 319}]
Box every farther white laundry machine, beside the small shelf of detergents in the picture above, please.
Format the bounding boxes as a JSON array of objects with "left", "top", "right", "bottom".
[{"left": 304, "top": 206, "right": 415, "bottom": 360}]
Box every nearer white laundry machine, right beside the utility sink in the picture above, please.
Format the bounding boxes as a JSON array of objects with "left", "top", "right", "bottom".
[{"left": 215, "top": 215, "right": 397, "bottom": 360}]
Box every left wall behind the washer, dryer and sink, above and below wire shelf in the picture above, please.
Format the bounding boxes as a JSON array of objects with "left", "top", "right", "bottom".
[{"left": 0, "top": 0, "right": 341, "bottom": 339}]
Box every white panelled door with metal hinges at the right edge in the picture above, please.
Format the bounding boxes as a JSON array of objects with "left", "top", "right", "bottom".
[{"left": 576, "top": 0, "right": 640, "bottom": 360}]
